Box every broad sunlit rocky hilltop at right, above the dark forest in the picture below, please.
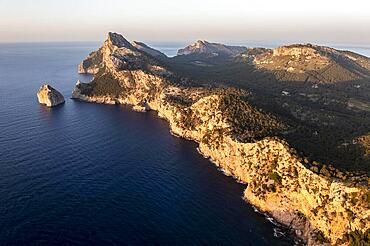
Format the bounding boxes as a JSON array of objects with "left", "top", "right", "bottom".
[{"left": 240, "top": 44, "right": 370, "bottom": 83}]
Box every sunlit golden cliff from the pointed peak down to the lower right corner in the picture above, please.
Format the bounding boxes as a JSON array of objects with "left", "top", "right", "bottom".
[{"left": 72, "top": 33, "right": 370, "bottom": 245}]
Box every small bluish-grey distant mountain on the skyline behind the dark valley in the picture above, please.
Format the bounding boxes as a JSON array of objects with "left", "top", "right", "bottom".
[{"left": 177, "top": 40, "right": 247, "bottom": 56}]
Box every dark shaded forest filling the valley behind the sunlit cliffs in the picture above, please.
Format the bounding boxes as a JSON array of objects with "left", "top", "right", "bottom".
[{"left": 166, "top": 45, "right": 370, "bottom": 174}]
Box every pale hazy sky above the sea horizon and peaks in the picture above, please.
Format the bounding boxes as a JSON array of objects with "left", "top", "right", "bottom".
[{"left": 0, "top": 0, "right": 370, "bottom": 45}]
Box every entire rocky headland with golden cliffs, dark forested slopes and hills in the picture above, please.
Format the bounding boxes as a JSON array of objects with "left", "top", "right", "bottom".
[{"left": 72, "top": 33, "right": 370, "bottom": 245}]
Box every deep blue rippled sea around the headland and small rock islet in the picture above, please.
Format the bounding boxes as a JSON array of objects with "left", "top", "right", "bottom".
[{"left": 0, "top": 43, "right": 369, "bottom": 245}]
